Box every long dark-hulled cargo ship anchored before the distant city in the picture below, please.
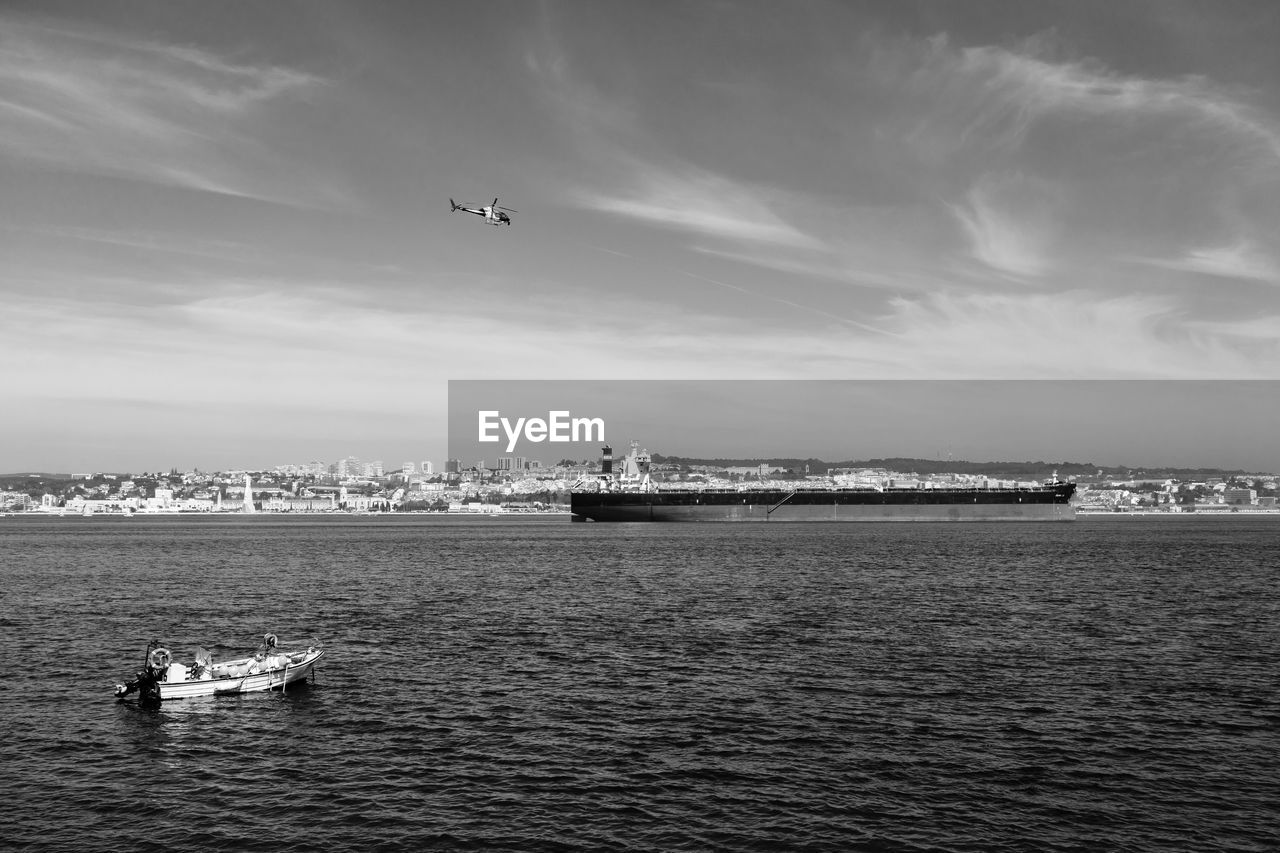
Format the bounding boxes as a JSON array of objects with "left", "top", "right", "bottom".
[{"left": 570, "top": 446, "right": 1075, "bottom": 521}]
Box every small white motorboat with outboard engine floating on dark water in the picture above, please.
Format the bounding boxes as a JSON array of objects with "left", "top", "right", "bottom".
[{"left": 115, "top": 634, "right": 324, "bottom": 702}]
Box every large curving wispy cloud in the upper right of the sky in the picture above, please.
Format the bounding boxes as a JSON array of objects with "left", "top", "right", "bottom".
[{"left": 876, "top": 37, "right": 1280, "bottom": 298}]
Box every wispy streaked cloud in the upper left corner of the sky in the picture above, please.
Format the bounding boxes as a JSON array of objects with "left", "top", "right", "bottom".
[{"left": 0, "top": 19, "right": 323, "bottom": 204}]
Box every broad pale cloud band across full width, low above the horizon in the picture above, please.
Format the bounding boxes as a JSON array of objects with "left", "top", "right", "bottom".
[{"left": 0, "top": 266, "right": 1280, "bottom": 467}]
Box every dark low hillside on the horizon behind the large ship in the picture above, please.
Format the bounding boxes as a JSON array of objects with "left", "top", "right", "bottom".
[{"left": 653, "top": 453, "right": 1258, "bottom": 482}]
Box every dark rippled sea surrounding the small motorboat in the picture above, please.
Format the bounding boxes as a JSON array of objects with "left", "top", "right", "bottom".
[{"left": 0, "top": 515, "right": 1280, "bottom": 852}]
